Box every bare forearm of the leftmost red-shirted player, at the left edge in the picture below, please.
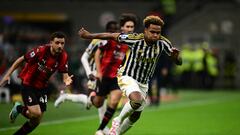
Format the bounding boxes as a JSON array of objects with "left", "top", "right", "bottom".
[{"left": 0, "top": 56, "right": 24, "bottom": 87}]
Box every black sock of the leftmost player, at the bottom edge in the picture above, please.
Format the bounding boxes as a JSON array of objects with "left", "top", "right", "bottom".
[{"left": 13, "top": 121, "right": 37, "bottom": 135}]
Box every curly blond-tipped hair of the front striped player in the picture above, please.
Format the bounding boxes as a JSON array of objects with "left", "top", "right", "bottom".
[{"left": 143, "top": 15, "right": 164, "bottom": 28}]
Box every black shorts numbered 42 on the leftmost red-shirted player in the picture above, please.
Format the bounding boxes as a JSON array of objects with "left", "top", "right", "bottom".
[{"left": 21, "top": 85, "right": 47, "bottom": 112}]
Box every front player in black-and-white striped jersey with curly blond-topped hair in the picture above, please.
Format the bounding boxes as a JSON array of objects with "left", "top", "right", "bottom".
[{"left": 79, "top": 15, "right": 182, "bottom": 135}]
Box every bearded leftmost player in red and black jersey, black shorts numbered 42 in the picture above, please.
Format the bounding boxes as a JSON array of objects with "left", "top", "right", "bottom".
[{"left": 0, "top": 32, "right": 73, "bottom": 135}]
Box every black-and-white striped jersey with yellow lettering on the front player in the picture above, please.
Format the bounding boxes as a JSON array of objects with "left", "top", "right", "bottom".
[{"left": 118, "top": 33, "right": 172, "bottom": 84}]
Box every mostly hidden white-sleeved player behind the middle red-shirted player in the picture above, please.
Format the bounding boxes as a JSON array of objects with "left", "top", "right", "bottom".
[{"left": 54, "top": 21, "right": 118, "bottom": 133}]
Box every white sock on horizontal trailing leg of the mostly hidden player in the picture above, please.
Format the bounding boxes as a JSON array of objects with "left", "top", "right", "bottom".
[{"left": 65, "top": 94, "right": 87, "bottom": 105}]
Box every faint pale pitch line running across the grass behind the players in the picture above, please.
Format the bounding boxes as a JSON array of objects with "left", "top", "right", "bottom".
[{"left": 0, "top": 98, "right": 236, "bottom": 131}]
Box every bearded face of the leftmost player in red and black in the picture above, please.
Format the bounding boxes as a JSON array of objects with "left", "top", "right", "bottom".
[{"left": 50, "top": 38, "right": 65, "bottom": 54}]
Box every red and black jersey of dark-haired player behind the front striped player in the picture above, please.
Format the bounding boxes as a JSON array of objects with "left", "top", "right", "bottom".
[{"left": 99, "top": 40, "right": 128, "bottom": 78}]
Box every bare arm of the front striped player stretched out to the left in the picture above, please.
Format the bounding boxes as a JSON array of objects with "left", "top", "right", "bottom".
[{"left": 78, "top": 28, "right": 120, "bottom": 40}]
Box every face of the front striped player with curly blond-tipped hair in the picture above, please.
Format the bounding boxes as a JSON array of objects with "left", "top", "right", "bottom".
[{"left": 144, "top": 24, "right": 161, "bottom": 42}]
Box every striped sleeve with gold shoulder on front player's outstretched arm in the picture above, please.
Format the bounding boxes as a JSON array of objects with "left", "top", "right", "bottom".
[{"left": 117, "top": 33, "right": 144, "bottom": 47}]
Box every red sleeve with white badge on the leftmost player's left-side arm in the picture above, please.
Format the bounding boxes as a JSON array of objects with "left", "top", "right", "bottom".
[{"left": 24, "top": 46, "right": 43, "bottom": 63}]
